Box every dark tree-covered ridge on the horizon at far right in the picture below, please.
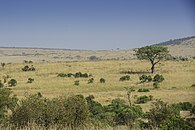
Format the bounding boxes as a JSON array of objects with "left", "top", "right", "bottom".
[{"left": 153, "top": 36, "right": 195, "bottom": 46}]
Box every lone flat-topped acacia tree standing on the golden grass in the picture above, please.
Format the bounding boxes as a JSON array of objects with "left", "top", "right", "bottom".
[{"left": 134, "top": 46, "right": 169, "bottom": 73}]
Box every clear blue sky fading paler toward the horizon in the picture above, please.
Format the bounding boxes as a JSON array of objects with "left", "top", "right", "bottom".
[{"left": 0, "top": 0, "right": 195, "bottom": 50}]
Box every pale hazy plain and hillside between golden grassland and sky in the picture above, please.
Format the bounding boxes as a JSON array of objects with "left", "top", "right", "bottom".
[{"left": 0, "top": 37, "right": 195, "bottom": 63}]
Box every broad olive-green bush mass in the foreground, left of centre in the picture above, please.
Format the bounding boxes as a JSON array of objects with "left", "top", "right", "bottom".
[{"left": 11, "top": 94, "right": 89, "bottom": 129}]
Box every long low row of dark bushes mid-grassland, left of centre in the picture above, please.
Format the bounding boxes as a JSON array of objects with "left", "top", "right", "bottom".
[{"left": 57, "top": 72, "right": 91, "bottom": 78}]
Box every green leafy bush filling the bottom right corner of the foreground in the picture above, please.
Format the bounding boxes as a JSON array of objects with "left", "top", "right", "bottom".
[{"left": 146, "top": 100, "right": 193, "bottom": 130}]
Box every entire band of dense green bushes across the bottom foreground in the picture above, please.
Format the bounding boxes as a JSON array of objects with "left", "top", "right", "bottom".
[{"left": 0, "top": 88, "right": 195, "bottom": 130}]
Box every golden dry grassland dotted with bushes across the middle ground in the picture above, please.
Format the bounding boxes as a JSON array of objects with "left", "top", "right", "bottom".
[{"left": 0, "top": 60, "right": 195, "bottom": 110}]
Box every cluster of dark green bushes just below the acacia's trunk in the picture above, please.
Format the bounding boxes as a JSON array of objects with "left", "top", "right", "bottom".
[{"left": 139, "top": 74, "right": 165, "bottom": 88}]
